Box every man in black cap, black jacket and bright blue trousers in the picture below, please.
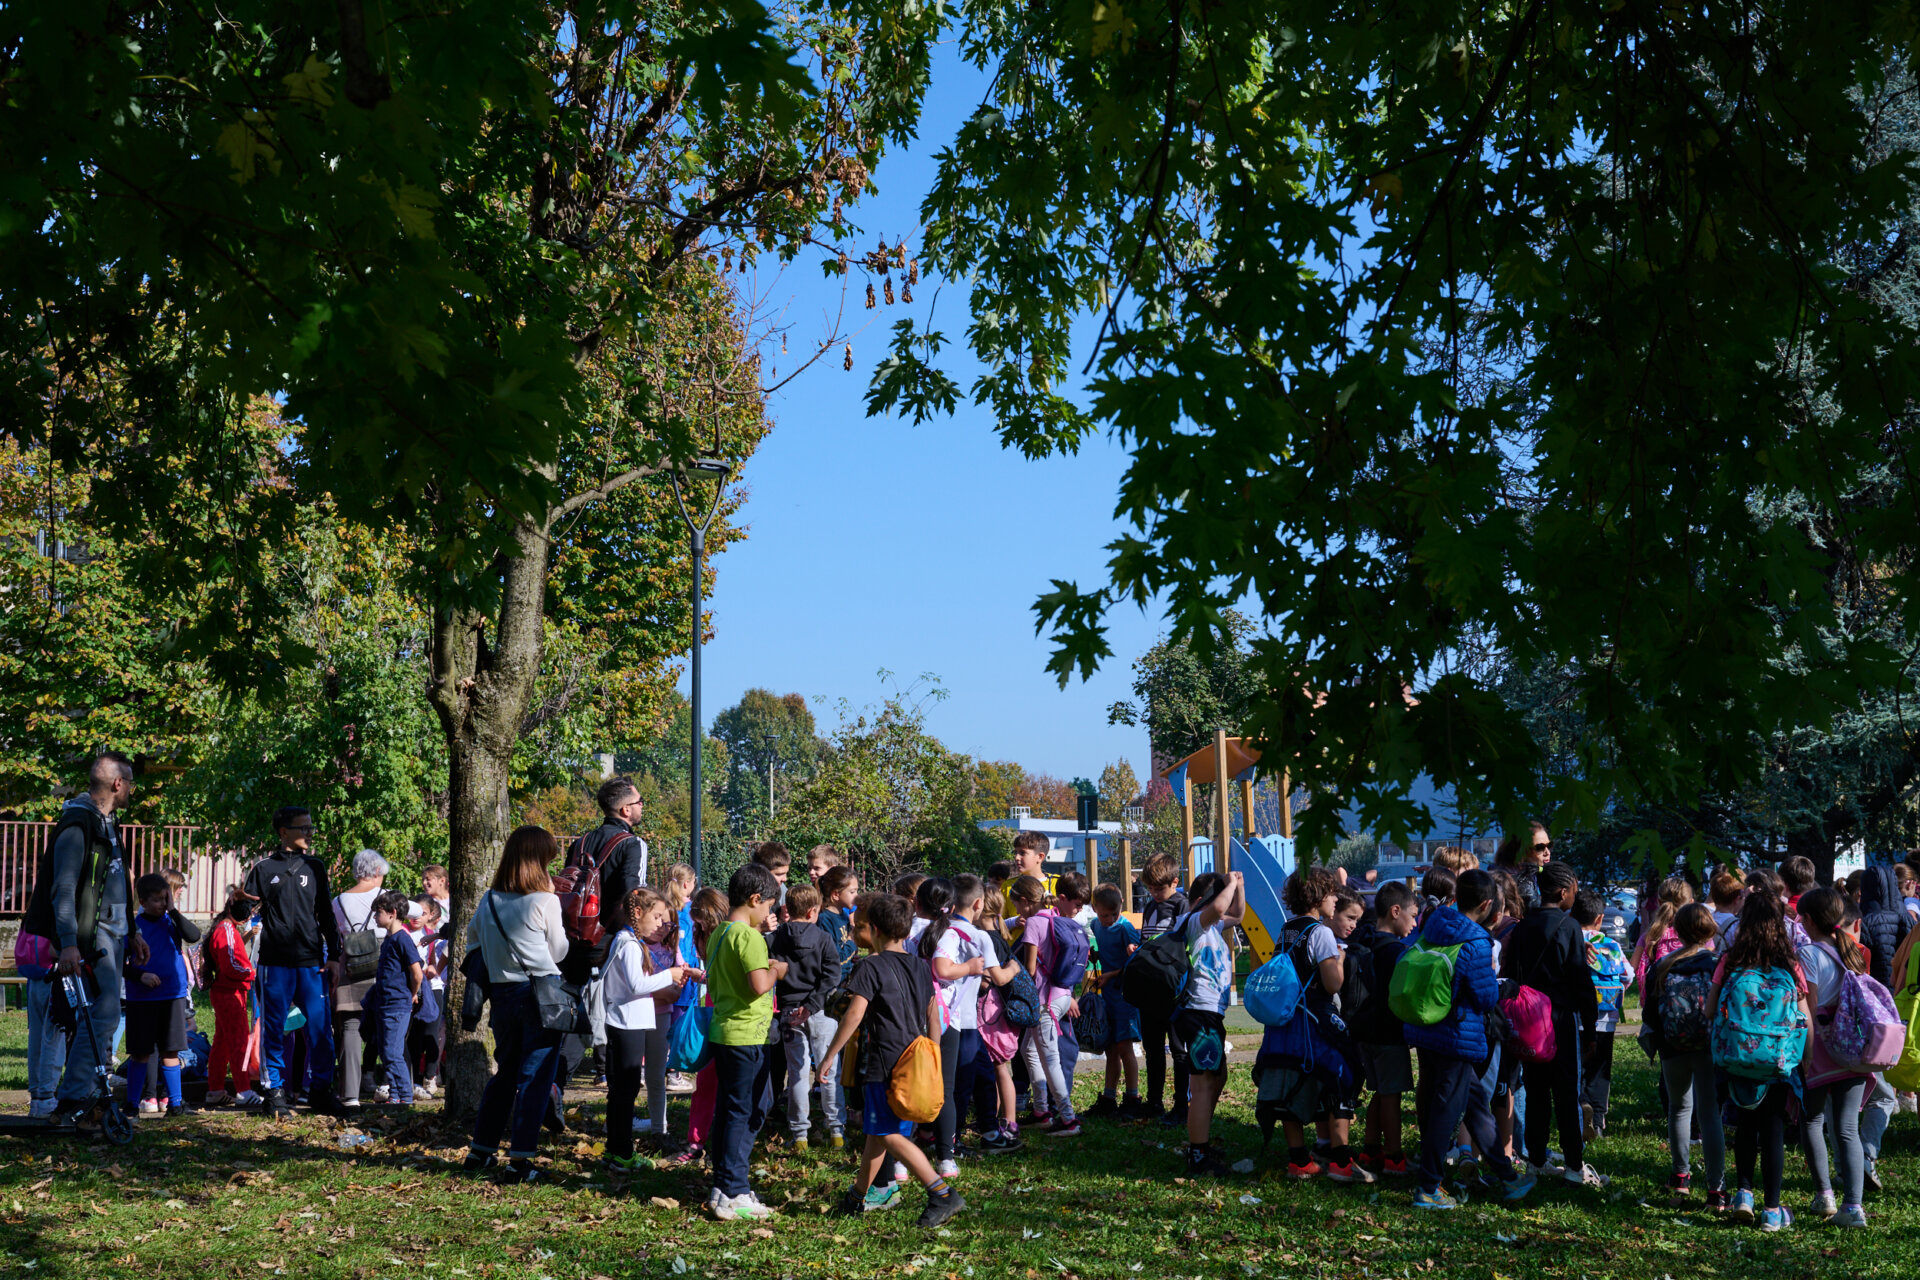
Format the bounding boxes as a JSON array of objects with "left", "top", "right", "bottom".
[{"left": 240, "top": 804, "right": 340, "bottom": 1115}]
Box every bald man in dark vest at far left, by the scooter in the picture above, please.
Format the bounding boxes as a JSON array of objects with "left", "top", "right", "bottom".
[{"left": 21, "top": 750, "right": 148, "bottom": 1125}]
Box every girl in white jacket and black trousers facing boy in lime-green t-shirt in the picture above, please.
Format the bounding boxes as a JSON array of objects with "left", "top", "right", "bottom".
[{"left": 601, "top": 889, "right": 707, "bottom": 1173}]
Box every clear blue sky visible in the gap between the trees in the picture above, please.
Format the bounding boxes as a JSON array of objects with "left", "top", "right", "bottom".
[{"left": 682, "top": 50, "right": 1162, "bottom": 781}]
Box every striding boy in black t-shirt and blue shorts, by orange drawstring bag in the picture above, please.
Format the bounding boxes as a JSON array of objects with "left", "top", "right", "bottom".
[{"left": 816, "top": 894, "right": 966, "bottom": 1226}]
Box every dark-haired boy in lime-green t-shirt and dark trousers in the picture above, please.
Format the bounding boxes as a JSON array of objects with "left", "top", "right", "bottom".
[{"left": 707, "top": 862, "right": 787, "bottom": 1222}]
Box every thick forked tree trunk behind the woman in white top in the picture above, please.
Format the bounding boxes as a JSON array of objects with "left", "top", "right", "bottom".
[{"left": 428, "top": 502, "right": 549, "bottom": 1117}]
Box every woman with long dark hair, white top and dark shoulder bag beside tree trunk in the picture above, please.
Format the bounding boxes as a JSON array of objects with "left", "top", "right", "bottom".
[{"left": 467, "top": 827, "right": 566, "bottom": 1182}]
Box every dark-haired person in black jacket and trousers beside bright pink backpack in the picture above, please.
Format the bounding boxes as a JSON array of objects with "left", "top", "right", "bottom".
[{"left": 1500, "top": 862, "right": 1607, "bottom": 1186}]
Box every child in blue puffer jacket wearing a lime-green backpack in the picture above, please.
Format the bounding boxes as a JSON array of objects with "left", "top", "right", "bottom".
[{"left": 1402, "top": 871, "right": 1534, "bottom": 1209}]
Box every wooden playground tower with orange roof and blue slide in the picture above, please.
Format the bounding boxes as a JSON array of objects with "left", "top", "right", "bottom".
[{"left": 1152, "top": 729, "right": 1296, "bottom": 963}]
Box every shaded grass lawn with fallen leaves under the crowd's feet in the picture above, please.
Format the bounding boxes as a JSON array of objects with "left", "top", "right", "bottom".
[{"left": 0, "top": 1013, "right": 1920, "bottom": 1280}]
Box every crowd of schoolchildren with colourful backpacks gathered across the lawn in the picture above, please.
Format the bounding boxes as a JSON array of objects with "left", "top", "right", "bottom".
[{"left": 35, "top": 809, "right": 1920, "bottom": 1230}]
